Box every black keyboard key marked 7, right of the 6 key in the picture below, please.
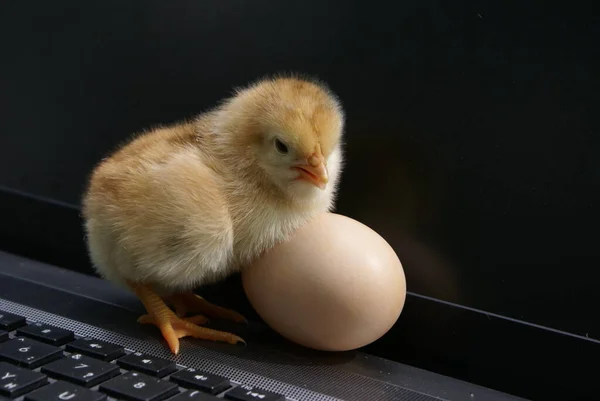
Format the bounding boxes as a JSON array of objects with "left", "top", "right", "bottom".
[{"left": 42, "top": 354, "right": 120, "bottom": 387}]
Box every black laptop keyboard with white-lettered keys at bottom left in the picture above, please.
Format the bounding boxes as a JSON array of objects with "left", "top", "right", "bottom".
[{"left": 0, "top": 311, "right": 286, "bottom": 401}]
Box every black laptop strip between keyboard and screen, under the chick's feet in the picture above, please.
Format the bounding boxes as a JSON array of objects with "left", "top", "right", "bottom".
[{"left": 0, "top": 252, "right": 524, "bottom": 401}]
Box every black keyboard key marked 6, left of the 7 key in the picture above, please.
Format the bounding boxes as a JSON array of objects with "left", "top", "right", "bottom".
[{"left": 0, "top": 337, "right": 63, "bottom": 369}]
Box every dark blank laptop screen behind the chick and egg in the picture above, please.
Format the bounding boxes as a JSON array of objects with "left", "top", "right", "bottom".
[{"left": 0, "top": 0, "right": 600, "bottom": 398}]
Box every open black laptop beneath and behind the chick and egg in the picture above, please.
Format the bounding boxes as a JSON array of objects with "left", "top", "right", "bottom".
[{"left": 0, "top": 0, "right": 600, "bottom": 401}]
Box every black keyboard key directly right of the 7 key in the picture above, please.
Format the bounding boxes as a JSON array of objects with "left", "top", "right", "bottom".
[{"left": 100, "top": 372, "right": 179, "bottom": 401}]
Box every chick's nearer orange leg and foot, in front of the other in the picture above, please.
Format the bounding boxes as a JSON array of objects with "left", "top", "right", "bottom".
[{"left": 130, "top": 284, "right": 244, "bottom": 355}]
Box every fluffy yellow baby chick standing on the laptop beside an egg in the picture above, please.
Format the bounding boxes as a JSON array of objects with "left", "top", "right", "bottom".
[{"left": 83, "top": 76, "right": 344, "bottom": 354}]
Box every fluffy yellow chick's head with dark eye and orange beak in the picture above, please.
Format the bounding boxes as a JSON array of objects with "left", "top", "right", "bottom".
[{"left": 218, "top": 78, "right": 344, "bottom": 200}]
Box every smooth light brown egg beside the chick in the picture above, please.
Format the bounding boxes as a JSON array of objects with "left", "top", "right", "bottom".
[{"left": 242, "top": 213, "right": 406, "bottom": 351}]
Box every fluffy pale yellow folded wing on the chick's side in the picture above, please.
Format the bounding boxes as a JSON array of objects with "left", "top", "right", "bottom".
[{"left": 84, "top": 133, "right": 233, "bottom": 289}]
